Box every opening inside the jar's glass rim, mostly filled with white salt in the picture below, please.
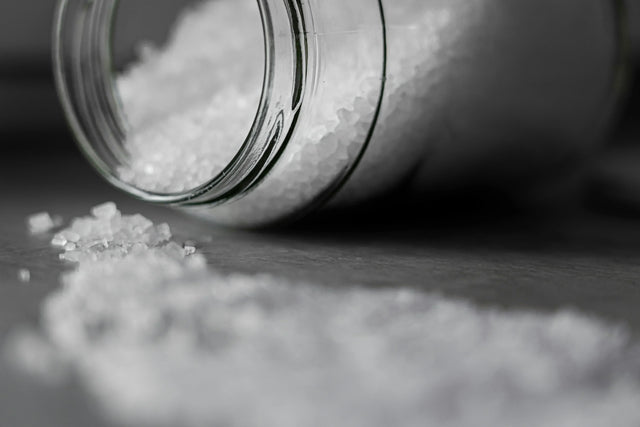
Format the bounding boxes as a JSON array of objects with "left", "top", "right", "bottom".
[{"left": 112, "top": 0, "right": 265, "bottom": 194}]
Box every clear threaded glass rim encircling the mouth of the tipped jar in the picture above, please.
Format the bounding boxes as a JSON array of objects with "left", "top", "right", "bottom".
[{"left": 54, "top": 0, "right": 307, "bottom": 205}]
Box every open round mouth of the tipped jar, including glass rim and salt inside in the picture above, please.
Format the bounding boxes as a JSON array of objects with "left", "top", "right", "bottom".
[{"left": 54, "top": 0, "right": 307, "bottom": 205}]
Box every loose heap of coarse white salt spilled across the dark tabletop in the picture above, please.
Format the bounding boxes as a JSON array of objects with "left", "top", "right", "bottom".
[{"left": 8, "top": 204, "right": 640, "bottom": 427}]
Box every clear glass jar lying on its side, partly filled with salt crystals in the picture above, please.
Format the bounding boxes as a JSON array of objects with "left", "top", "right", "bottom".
[{"left": 55, "top": 0, "right": 626, "bottom": 226}]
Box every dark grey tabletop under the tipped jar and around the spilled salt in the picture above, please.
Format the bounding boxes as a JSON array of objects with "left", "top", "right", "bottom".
[{"left": 0, "top": 149, "right": 640, "bottom": 427}]
